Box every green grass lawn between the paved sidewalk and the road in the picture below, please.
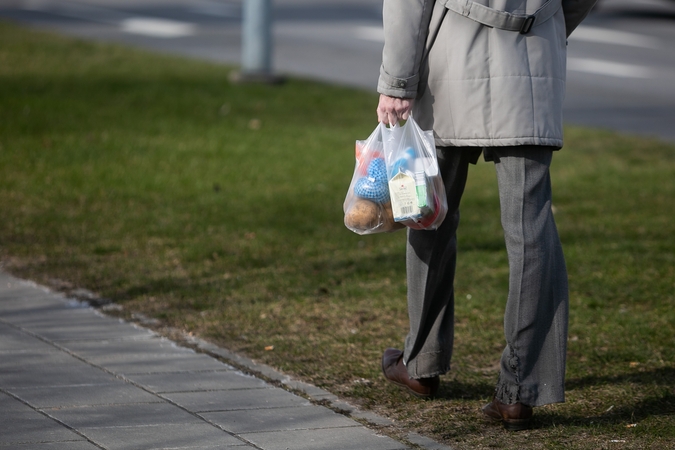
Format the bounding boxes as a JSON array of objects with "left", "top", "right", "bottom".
[{"left": 0, "top": 25, "right": 675, "bottom": 449}]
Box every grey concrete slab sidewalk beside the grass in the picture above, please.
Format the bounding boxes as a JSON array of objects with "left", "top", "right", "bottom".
[{"left": 0, "top": 272, "right": 454, "bottom": 450}]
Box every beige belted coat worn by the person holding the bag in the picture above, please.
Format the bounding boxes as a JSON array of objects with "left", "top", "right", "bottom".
[{"left": 378, "top": 0, "right": 596, "bottom": 148}]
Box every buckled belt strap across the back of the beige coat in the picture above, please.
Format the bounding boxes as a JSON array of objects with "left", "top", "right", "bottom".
[{"left": 440, "top": 0, "right": 562, "bottom": 34}]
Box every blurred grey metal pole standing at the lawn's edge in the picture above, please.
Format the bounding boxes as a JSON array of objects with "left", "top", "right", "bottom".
[{"left": 241, "top": 0, "right": 272, "bottom": 78}]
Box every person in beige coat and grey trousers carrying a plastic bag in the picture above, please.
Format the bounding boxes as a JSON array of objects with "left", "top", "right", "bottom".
[{"left": 377, "top": 0, "right": 596, "bottom": 430}]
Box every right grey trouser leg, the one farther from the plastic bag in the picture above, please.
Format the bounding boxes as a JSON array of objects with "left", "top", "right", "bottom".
[{"left": 490, "top": 146, "right": 569, "bottom": 406}]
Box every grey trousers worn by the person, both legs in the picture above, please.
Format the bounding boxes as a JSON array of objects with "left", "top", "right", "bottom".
[{"left": 404, "top": 146, "right": 569, "bottom": 406}]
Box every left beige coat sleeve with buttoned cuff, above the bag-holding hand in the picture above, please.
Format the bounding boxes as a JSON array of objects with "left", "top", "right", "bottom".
[{"left": 377, "top": 0, "right": 435, "bottom": 98}]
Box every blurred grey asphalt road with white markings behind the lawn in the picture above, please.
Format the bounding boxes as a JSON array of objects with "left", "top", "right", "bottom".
[{"left": 0, "top": 0, "right": 675, "bottom": 142}]
